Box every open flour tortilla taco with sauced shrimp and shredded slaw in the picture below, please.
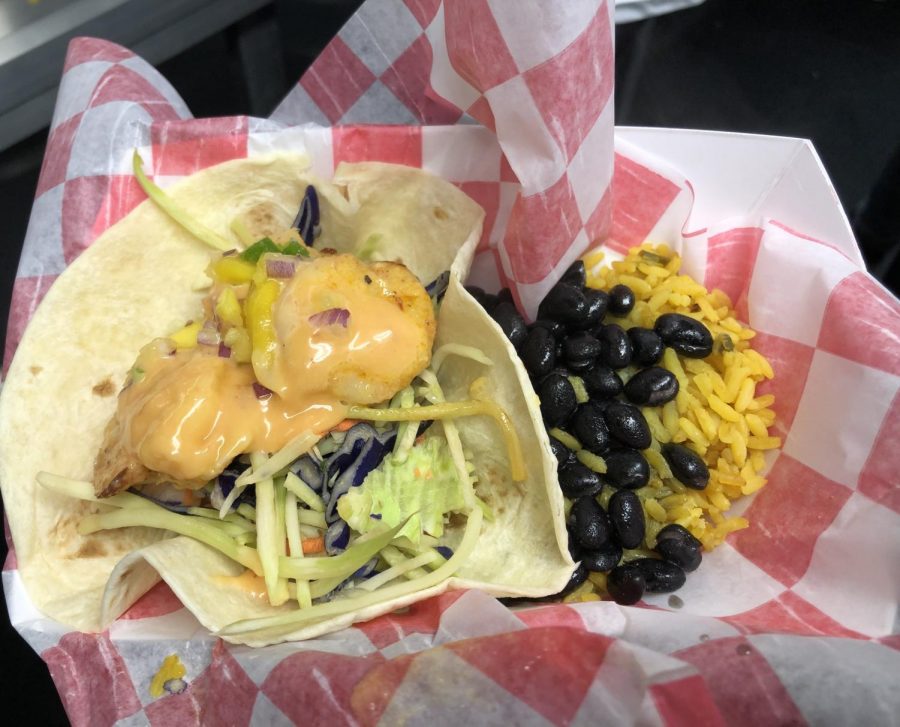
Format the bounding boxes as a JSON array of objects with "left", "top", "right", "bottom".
[{"left": 0, "top": 154, "right": 574, "bottom": 645}]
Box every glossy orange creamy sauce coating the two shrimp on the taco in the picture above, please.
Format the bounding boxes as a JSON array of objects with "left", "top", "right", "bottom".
[{"left": 118, "top": 255, "right": 435, "bottom": 487}]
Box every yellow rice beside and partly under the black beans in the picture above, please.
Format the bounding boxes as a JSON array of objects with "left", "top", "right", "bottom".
[{"left": 566, "top": 243, "right": 781, "bottom": 600}]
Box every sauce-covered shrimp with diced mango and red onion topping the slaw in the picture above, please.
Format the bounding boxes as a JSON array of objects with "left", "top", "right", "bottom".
[{"left": 94, "top": 253, "right": 436, "bottom": 497}]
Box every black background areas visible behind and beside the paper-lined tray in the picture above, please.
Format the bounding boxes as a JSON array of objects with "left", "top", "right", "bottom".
[{"left": 0, "top": 0, "right": 900, "bottom": 725}]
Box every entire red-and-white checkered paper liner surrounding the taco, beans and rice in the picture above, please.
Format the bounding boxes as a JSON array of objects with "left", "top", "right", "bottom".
[{"left": 3, "top": 0, "right": 900, "bottom": 725}]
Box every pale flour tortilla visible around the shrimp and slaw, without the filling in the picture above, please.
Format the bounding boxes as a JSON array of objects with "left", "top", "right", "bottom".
[{"left": 0, "top": 154, "right": 574, "bottom": 645}]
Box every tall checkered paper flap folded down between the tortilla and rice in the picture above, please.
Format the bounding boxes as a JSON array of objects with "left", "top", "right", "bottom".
[{"left": 272, "top": 0, "right": 615, "bottom": 313}]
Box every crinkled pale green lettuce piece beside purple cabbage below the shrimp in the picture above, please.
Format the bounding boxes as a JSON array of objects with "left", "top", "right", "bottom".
[{"left": 337, "top": 437, "right": 465, "bottom": 544}]
